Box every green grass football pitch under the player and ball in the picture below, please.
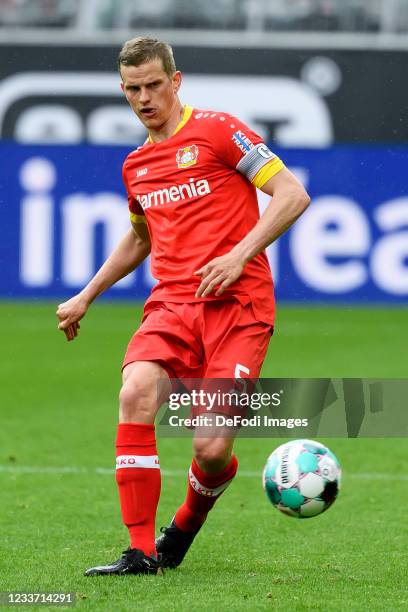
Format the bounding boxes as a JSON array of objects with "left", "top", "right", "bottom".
[{"left": 0, "top": 302, "right": 408, "bottom": 612}]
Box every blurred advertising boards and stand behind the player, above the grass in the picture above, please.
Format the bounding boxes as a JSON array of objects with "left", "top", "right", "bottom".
[{"left": 0, "top": 0, "right": 408, "bottom": 304}]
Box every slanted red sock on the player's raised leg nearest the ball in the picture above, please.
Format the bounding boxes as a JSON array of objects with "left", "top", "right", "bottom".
[{"left": 175, "top": 455, "right": 238, "bottom": 532}]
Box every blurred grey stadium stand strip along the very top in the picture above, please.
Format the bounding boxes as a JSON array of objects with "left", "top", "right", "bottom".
[{"left": 0, "top": 0, "right": 408, "bottom": 34}]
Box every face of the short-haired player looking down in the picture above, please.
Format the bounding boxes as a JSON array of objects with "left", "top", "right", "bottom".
[{"left": 120, "top": 59, "right": 181, "bottom": 130}]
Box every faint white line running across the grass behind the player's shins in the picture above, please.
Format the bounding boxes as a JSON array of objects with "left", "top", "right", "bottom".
[{"left": 0, "top": 465, "right": 408, "bottom": 481}]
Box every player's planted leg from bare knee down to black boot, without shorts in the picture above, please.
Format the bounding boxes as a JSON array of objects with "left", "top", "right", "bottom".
[{"left": 86, "top": 361, "right": 170, "bottom": 576}]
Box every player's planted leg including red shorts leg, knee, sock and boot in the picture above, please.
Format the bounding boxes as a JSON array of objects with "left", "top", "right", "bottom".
[{"left": 86, "top": 303, "right": 201, "bottom": 575}]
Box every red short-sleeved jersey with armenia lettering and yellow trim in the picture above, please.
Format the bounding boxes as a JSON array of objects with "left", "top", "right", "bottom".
[{"left": 123, "top": 106, "right": 284, "bottom": 324}]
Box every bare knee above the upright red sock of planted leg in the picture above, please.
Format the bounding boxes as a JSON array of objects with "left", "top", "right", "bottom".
[{"left": 119, "top": 380, "right": 157, "bottom": 423}]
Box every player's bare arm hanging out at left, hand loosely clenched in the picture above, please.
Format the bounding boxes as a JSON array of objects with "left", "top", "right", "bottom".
[{"left": 57, "top": 222, "right": 151, "bottom": 341}]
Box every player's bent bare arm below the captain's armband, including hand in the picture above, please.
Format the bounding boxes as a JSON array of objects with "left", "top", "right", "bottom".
[{"left": 196, "top": 167, "right": 310, "bottom": 297}]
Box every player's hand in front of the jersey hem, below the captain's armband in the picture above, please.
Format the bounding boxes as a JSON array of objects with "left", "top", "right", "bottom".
[{"left": 194, "top": 253, "right": 244, "bottom": 297}]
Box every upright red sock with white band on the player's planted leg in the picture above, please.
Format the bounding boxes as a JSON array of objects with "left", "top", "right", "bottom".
[{"left": 116, "top": 423, "right": 161, "bottom": 555}]
